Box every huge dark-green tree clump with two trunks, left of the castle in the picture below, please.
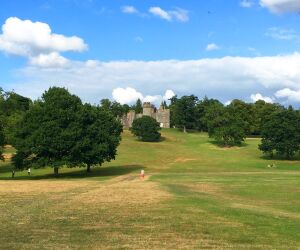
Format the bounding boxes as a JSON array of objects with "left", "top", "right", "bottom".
[{"left": 13, "top": 87, "right": 122, "bottom": 175}]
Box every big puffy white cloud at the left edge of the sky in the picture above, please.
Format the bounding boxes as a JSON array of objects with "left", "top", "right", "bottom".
[{"left": 0, "top": 17, "right": 87, "bottom": 57}]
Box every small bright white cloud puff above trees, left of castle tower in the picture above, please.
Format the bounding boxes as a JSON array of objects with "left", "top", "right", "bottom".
[{"left": 112, "top": 87, "right": 143, "bottom": 104}]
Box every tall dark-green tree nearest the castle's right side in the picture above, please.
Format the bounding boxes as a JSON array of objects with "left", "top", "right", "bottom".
[{"left": 170, "top": 95, "right": 198, "bottom": 132}]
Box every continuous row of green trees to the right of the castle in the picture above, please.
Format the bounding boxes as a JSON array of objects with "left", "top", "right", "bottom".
[{"left": 169, "top": 95, "right": 300, "bottom": 158}]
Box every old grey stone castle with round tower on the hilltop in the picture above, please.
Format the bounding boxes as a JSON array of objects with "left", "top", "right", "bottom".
[{"left": 122, "top": 102, "right": 170, "bottom": 128}]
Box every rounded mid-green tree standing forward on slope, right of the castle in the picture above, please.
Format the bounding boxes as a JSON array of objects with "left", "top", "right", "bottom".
[{"left": 207, "top": 105, "right": 248, "bottom": 146}]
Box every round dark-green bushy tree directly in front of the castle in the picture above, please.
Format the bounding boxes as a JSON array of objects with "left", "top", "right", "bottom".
[{"left": 130, "top": 116, "right": 161, "bottom": 142}]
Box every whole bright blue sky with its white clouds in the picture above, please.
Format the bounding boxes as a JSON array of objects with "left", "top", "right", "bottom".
[{"left": 0, "top": 0, "right": 300, "bottom": 107}]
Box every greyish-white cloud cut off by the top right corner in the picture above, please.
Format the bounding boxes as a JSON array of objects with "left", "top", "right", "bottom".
[{"left": 260, "top": 0, "right": 300, "bottom": 13}]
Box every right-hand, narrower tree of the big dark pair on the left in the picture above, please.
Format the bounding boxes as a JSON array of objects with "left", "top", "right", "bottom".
[{"left": 72, "top": 104, "right": 123, "bottom": 172}]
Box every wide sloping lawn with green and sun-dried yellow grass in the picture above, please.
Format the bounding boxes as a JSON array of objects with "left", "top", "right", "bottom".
[{"left": 0, "top": 129, "right": 300, "bottom": 249}]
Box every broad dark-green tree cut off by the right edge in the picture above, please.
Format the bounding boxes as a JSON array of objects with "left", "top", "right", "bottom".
[{"left": 259, "top": 107, "right": 300, "bottom": 159}]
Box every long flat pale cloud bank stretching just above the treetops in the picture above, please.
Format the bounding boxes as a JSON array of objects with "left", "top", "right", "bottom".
[{"left": 10, "top": 53, "right": 300, "bottom": 103}]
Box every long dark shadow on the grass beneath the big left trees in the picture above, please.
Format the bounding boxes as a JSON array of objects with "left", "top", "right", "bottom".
[{"left": 0, "top": 165, "right": 145, "bottom": 180}]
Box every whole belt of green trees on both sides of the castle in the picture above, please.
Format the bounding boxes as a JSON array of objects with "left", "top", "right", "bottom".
[{"left": 0, "top": 87, "right": 300, "bottom": 174}]
